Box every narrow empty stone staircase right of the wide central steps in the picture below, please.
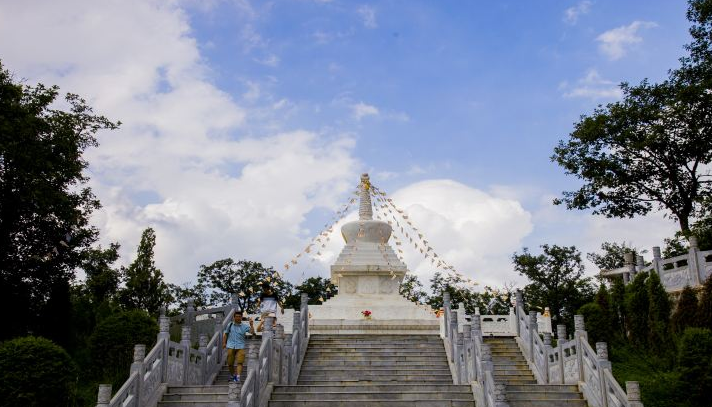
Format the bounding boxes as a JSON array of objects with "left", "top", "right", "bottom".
[{"left": 484, "top": 337, "right": 587, "bottom": 407}]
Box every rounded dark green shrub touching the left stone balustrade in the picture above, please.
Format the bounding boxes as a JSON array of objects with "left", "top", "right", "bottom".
[{"left": 89, "top": 310, "right": 158, "bottom": 388}]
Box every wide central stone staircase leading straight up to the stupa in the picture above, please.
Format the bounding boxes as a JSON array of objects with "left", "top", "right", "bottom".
[{"left": 269, "top": 334, "right": 475, "bottom": 407}]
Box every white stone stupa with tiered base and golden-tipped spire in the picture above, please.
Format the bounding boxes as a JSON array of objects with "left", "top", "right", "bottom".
[{"left": 309, "top": 174, "right": 439, "bottom": 334}]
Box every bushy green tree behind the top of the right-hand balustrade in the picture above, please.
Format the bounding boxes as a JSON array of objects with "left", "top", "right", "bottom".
[{"left": 512, "top": 244, "right": 594, "bottom": 325}]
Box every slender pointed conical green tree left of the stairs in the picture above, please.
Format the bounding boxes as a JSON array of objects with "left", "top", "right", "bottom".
[{"left": 119, "top": 228, "right": 170, "bottom": 315}]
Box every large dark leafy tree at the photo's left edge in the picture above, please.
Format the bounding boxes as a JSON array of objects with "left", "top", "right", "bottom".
[{"left": 0, "top": 63, "right": 118, "bottom": 338}]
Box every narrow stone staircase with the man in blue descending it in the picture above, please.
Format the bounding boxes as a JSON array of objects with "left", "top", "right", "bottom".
[{"left": 158, "top": 336, "right": 261, "bottom": 407}]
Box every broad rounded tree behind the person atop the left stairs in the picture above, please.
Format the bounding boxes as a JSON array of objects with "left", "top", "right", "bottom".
[{"left": 198, "top": 258, "right": 292, "bottom": 313}]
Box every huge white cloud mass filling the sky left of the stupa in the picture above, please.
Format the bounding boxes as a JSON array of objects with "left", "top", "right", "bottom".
[{"left": 0, "top": 0, "right": 359, "bottom": 282}]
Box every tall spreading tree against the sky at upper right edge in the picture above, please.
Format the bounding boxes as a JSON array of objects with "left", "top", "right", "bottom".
[{"left": 551, "top": 0, "right": 712, "bottom": 236}]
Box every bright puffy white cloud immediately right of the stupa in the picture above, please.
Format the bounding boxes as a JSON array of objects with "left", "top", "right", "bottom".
[{"left": 384, "top": 180, "right": 533, "bottom": 287}]
